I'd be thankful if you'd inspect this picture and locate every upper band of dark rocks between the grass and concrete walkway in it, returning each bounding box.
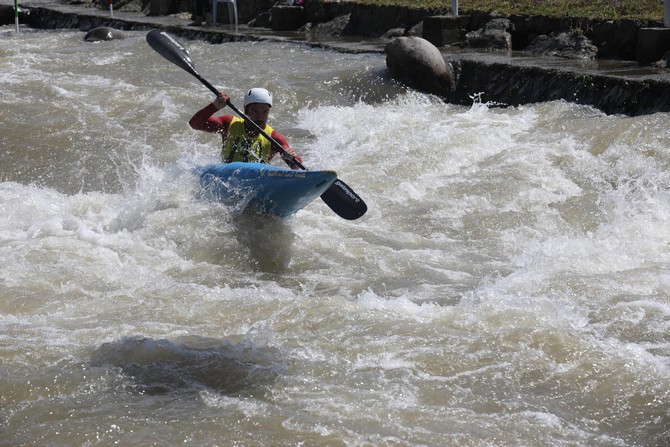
[46,0,670,63]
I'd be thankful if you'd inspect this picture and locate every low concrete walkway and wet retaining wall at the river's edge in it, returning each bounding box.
[0,0,670,116]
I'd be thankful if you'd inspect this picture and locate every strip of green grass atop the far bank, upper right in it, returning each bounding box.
[355,0,663,22]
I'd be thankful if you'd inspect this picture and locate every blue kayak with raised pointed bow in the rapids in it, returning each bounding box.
[198,162,337,217]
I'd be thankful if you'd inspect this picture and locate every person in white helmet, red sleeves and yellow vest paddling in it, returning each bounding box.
[188,88,302,169]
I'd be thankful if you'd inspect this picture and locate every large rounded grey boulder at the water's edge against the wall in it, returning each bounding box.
[385,36,454,96]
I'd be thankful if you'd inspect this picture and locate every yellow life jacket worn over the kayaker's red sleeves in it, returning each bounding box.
[221,117,272,163]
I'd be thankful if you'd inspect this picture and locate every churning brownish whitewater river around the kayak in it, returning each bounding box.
[0,27,670,447]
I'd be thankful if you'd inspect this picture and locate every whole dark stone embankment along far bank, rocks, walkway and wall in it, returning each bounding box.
[0,0,670,115]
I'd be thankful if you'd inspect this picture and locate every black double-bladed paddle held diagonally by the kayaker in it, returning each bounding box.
[147,29,368,220]
